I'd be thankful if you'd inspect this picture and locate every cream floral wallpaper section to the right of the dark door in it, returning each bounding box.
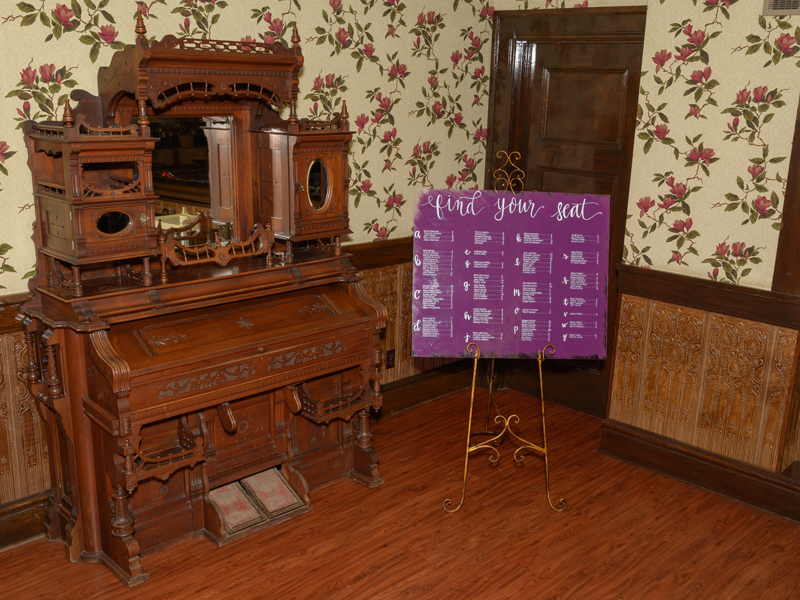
[624,0,800,289]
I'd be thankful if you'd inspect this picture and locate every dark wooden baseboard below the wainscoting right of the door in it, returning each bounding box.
[598,420,800,522]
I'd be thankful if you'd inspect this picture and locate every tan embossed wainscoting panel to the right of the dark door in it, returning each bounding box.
[609,294,798,472]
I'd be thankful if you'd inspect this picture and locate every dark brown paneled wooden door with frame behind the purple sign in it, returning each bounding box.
[484,6,647,417]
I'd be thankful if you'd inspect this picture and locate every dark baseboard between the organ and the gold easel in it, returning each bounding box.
[375,359,473,419]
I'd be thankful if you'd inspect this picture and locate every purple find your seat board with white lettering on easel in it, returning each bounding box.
[412,190,610,359]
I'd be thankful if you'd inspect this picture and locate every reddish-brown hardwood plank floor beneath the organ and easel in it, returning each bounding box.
[0,390,800,600]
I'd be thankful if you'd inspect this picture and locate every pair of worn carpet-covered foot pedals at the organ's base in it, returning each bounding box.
[208,468,310,534]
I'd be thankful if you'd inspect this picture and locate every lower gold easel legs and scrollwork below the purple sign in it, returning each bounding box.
[442,342,567,513]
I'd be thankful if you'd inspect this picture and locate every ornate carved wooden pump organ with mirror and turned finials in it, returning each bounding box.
[21,17,386,586]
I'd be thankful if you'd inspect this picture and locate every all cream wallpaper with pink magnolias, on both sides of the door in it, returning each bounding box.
[0,0,800,293]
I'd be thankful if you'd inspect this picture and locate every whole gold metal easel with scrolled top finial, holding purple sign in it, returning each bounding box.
[442,150,567,513]
